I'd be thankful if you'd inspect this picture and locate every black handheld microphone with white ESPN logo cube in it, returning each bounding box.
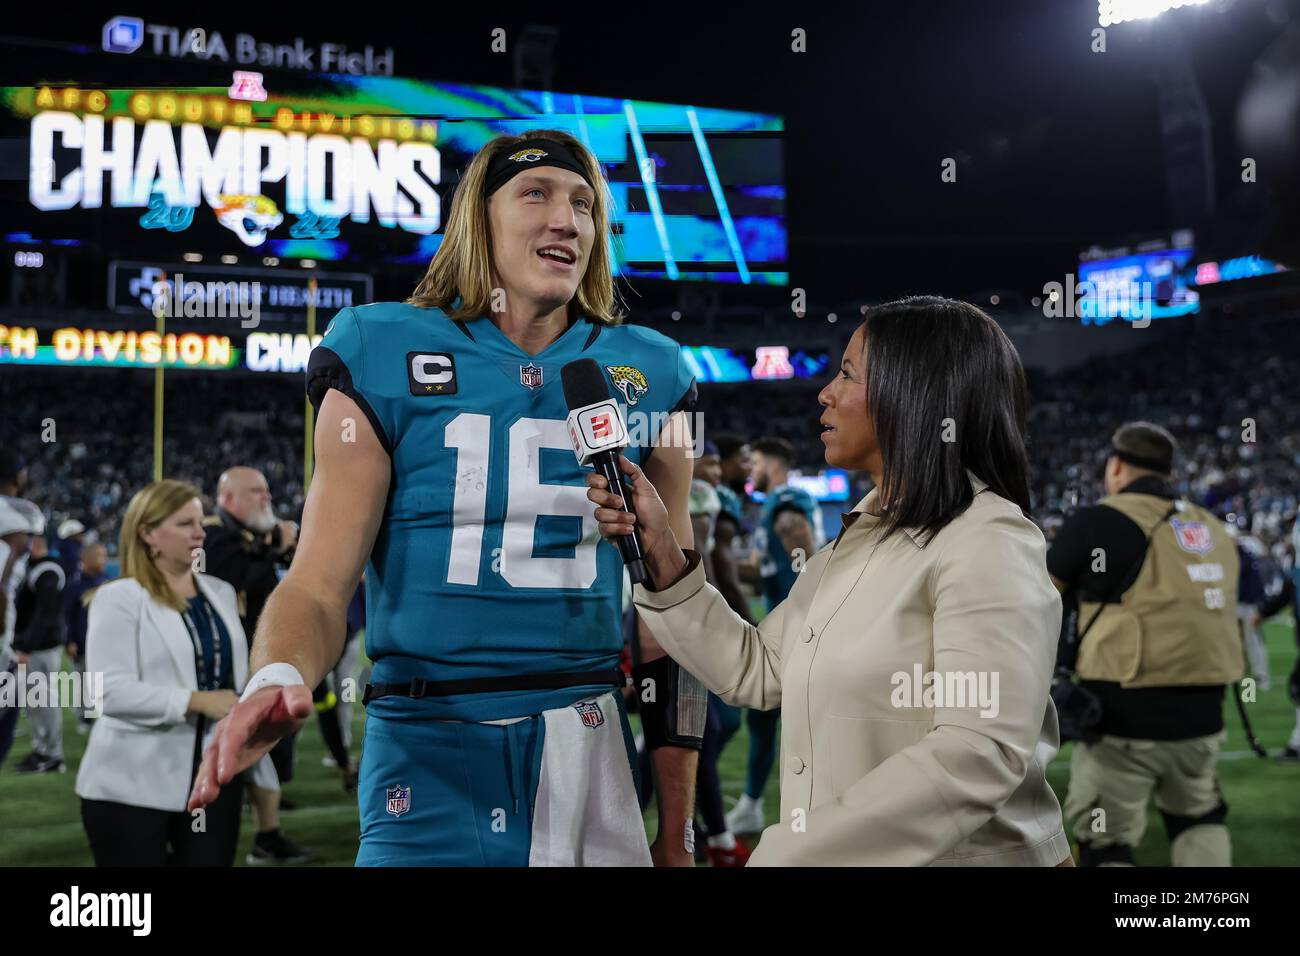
[560,359,650,584]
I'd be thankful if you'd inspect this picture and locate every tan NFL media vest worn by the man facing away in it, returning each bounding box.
[1078,493,1245,688]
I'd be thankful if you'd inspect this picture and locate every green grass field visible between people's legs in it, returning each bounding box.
[0,619,1300,866]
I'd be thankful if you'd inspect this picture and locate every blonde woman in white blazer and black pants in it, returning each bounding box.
[77,481,276,866]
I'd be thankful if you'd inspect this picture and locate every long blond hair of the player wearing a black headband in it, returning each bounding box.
[407,130,624,325]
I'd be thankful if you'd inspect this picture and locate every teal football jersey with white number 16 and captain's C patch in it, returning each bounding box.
[307,303,696,721]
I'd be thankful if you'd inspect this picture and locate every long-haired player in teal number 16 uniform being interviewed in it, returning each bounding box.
[190,130,705,865]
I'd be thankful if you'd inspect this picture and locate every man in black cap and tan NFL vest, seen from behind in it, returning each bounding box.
[1048,421,1245,866]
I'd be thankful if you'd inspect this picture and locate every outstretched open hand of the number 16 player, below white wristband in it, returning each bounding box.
[186,685,312,810]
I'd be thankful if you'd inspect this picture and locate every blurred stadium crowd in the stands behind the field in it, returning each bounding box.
[0,306,1300,564]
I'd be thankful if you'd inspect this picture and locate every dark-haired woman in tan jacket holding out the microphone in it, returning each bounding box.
[588,297,1070,866]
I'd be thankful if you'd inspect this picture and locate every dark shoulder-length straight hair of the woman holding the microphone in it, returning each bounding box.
[863,295,1030,542]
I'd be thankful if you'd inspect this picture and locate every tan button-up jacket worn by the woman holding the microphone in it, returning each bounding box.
[633,476,1070,866]
